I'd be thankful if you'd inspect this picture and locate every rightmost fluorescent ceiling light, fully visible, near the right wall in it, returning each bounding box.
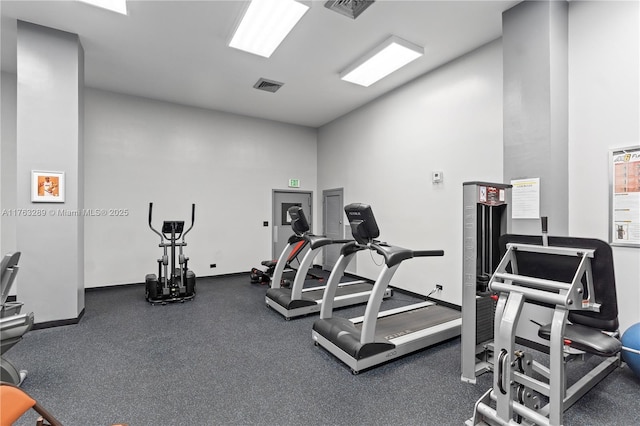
[340,36,424,87]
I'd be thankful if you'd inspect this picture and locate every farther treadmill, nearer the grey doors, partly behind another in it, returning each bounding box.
[265,206,393,320]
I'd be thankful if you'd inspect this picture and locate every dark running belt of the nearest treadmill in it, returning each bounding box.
[356,305,461,340]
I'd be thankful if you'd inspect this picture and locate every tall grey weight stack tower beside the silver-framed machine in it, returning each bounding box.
[461,182,511,383]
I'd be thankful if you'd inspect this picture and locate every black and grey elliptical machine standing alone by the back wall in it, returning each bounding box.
[145,203,196,305]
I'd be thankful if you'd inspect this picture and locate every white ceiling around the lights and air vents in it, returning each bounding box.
[0,0,519,127]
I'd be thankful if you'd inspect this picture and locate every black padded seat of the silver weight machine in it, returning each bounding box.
[538,324,622,356]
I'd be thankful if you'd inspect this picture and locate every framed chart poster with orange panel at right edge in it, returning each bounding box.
[609,146,640,247]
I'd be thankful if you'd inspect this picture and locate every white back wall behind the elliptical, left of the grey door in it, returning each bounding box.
[85,89,316,287]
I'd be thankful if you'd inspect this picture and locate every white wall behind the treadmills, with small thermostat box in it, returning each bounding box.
[318,40,502,304]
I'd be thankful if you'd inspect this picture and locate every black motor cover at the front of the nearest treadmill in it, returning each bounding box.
[313,318,396,359]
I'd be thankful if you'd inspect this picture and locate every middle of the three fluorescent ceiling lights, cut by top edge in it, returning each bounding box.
[229,0,309,58]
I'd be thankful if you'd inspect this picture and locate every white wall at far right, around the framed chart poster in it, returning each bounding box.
[569,1,640,330]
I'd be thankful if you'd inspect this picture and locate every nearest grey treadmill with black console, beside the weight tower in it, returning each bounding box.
[312,203,462,374]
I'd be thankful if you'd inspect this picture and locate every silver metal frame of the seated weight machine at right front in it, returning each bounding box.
[467,236,621,426]
